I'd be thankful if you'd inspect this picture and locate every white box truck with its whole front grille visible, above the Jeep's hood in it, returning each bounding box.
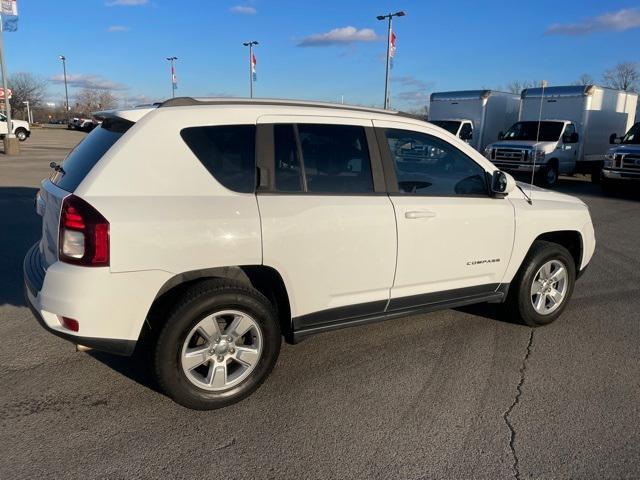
[484,85,638,186]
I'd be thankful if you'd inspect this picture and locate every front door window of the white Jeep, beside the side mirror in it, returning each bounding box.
[386,129,488,196]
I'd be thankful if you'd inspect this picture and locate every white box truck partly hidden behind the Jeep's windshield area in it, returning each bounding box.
[429,90,520,152]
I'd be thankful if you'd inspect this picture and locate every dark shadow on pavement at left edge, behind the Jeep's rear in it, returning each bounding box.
[0,187,42,306]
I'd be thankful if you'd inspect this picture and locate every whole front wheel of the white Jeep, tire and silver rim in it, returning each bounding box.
[505,241,576,327]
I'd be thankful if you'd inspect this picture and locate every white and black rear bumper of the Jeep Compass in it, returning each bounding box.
[23,244,171,355]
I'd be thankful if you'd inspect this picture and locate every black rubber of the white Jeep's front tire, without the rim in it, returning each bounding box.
[504,240,576,327]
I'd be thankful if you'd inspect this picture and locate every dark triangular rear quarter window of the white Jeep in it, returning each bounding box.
[180,125,256,193]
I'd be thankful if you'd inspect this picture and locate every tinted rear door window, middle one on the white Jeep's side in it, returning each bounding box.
[274,124,373,194]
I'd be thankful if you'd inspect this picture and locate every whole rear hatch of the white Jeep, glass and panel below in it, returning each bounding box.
[36,117,134,271]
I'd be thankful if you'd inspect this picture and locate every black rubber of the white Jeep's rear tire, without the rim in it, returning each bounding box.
[153,279,281,410]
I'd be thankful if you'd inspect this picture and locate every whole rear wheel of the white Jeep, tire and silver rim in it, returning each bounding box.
[154,280,281,410]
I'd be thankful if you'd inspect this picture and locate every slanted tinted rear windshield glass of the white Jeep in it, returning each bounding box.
[51,118,133,192]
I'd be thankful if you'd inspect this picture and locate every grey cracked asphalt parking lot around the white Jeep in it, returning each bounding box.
[0,130,640,479]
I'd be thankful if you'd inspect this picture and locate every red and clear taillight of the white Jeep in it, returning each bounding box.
[58,195,109,267]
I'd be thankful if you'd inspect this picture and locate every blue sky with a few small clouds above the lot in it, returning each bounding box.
[5,0,640,108]
